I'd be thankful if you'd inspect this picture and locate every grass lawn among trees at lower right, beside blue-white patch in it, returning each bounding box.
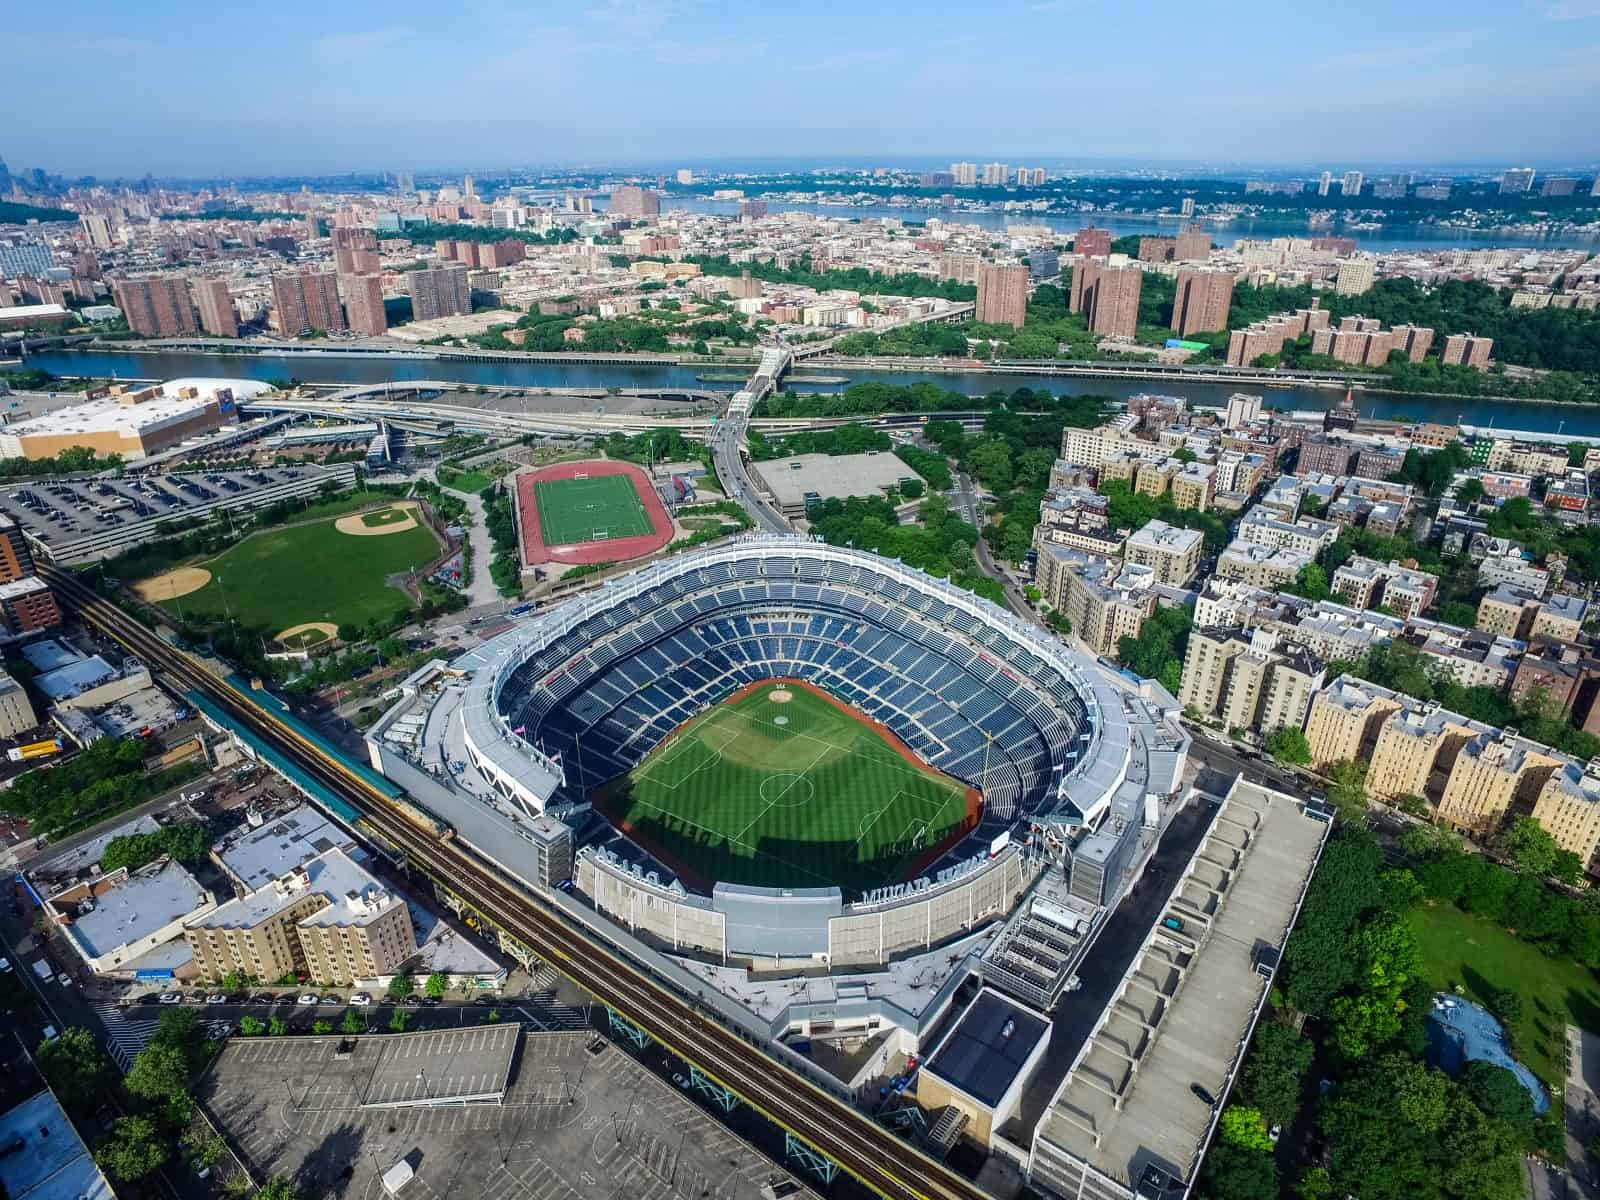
[1408,904,1600,1086]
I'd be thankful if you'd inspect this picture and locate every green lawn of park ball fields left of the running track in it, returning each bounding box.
[163,520,438,634]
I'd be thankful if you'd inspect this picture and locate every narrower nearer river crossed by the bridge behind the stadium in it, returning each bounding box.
[26,350,1600,437]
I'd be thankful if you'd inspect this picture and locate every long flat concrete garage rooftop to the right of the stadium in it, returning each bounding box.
[1035,779,1328,1190]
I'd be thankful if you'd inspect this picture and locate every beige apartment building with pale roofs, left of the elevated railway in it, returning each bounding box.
[184,848,416,987]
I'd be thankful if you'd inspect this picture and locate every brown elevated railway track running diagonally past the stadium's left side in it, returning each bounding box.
[50,565,986,1200]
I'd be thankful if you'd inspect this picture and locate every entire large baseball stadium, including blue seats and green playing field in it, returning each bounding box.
[454,534,1187,965]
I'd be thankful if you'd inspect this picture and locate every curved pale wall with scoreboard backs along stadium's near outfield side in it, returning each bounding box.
[576,846,1046,966]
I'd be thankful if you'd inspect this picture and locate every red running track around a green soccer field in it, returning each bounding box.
[517,461,672,566]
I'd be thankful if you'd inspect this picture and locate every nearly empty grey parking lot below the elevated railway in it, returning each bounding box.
[198,1026,810,1200]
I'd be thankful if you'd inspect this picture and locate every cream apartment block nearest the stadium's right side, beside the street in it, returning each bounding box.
[1178,627,1323,738]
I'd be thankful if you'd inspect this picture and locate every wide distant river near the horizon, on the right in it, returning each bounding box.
[643,197,1600,253]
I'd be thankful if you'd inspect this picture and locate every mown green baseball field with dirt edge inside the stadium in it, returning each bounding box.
[600,685,966,894]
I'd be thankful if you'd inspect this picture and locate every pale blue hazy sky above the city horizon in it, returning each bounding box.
[9,0,1600,178]
